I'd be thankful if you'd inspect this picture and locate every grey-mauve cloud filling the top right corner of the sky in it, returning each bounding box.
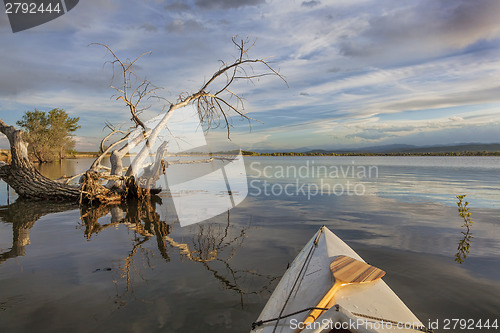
[340,0,500,61]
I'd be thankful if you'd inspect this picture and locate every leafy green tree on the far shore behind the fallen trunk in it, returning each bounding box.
[17,109,80,163]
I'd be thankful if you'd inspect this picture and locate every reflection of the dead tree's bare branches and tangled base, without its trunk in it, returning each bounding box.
[82,201,278,306]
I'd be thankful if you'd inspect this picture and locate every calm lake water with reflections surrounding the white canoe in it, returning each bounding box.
[0,157,500,332]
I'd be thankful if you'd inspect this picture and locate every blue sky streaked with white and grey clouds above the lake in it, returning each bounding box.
[0,0,500,151]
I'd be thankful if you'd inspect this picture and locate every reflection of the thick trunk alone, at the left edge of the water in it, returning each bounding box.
[0,199,78,262]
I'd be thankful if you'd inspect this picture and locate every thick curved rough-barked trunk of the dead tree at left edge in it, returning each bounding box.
[0,119,80,201]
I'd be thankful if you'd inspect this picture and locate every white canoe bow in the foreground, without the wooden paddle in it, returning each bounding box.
[252,227,428,333]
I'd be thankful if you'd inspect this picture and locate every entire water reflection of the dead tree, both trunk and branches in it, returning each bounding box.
[0,197,278,308]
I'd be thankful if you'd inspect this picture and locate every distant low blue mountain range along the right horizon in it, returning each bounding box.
[255,143,500,154]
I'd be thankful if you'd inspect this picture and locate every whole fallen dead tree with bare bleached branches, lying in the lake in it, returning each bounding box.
[0,38,286,204]
